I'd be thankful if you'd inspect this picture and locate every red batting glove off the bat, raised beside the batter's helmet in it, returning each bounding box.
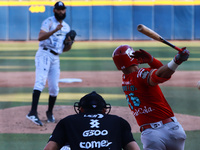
[131,49,153,64]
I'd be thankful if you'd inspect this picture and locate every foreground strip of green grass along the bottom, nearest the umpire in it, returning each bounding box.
[0,131,200,150]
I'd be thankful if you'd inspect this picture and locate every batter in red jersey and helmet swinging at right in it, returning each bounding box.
[112,45,189,150]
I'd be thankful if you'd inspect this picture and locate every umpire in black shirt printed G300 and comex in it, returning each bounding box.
[44,91,140,150]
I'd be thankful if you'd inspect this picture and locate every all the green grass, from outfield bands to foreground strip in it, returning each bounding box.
[0,41,200,150]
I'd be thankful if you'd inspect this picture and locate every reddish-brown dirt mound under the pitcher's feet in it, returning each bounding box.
[0,105,200,134]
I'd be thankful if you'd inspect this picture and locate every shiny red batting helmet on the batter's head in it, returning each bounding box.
[112,45,138,70]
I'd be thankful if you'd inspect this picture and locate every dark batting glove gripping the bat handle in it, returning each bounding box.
[174,47,190,65]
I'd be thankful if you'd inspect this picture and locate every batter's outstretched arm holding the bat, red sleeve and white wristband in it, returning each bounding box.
[149,49,189,86]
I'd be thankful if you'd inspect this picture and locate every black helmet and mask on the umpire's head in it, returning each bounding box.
[74,91,111,114]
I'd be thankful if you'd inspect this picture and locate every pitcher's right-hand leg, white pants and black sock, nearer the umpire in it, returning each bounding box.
[46,56,60,122]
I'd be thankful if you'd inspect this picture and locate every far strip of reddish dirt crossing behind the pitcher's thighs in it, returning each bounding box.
[0,71,200,87]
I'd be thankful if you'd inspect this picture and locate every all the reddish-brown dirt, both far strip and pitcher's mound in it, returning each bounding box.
[0,71,200,134]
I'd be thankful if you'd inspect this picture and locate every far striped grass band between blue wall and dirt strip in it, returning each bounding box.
[0,41,200,71]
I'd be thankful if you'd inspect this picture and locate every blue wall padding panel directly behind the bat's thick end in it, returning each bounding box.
[133,6,153,40]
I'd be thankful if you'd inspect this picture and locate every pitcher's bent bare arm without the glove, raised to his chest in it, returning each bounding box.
[38,24,63,41]
